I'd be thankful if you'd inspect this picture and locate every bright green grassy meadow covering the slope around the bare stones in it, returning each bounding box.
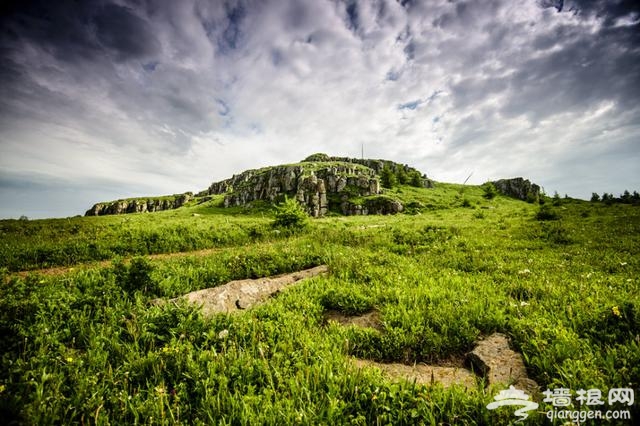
[0,184,640,425]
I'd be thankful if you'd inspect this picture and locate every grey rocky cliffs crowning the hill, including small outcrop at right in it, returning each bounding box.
[85,153,540,217]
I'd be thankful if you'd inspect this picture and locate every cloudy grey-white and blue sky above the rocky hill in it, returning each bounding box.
[0,0,640,218]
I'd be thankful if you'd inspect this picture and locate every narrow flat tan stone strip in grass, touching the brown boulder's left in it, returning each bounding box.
[352,358,477,389]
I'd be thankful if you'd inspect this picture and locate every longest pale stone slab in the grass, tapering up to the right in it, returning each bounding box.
[160,265,328,315]
